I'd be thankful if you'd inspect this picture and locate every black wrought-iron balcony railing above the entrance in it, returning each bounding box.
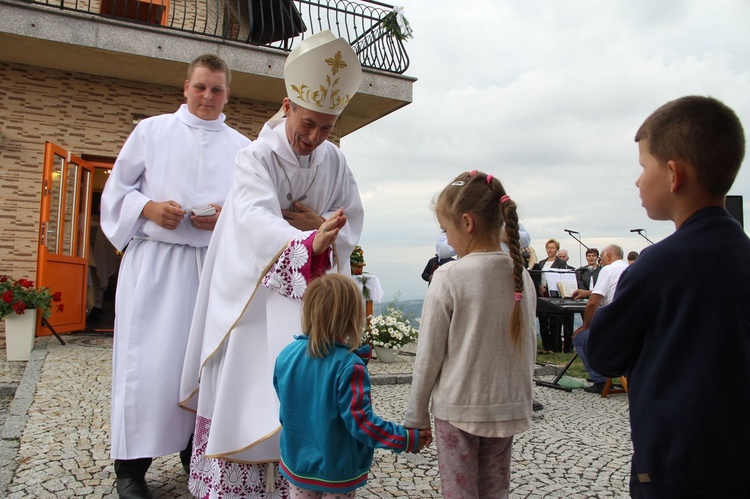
[22,0,409,74]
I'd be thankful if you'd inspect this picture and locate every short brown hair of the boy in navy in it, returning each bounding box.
[635,95,745,195]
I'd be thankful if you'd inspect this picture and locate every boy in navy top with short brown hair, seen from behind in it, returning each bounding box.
[587,96,750,499]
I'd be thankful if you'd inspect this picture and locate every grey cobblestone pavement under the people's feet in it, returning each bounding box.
[0,334,632,498]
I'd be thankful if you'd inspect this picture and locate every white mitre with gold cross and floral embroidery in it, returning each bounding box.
[284,30,362,116]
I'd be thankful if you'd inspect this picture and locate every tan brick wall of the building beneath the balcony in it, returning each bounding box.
[0,62,338,330]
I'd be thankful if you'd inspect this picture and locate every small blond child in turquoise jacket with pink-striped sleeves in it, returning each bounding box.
[273,274,432,498]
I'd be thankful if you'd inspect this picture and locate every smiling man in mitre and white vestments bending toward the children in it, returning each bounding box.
[181,31,363,498]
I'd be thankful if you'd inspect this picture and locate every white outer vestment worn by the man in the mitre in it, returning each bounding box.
[180,119,363,463]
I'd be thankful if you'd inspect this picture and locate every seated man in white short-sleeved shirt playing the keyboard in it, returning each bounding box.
[573,244,628,393]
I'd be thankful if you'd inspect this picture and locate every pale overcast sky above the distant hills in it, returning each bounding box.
[342,0,750,301]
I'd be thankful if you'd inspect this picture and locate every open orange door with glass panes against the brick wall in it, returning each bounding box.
[37,142,94,334]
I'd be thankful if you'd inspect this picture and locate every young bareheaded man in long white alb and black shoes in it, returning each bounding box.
[101,54,250,498]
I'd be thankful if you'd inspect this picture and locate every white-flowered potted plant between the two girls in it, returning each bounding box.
[364,303,419,362]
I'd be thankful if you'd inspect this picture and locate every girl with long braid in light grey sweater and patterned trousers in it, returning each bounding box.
[405,170,536,498]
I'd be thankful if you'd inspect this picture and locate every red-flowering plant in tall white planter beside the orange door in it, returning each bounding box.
[0,275,64,360]
